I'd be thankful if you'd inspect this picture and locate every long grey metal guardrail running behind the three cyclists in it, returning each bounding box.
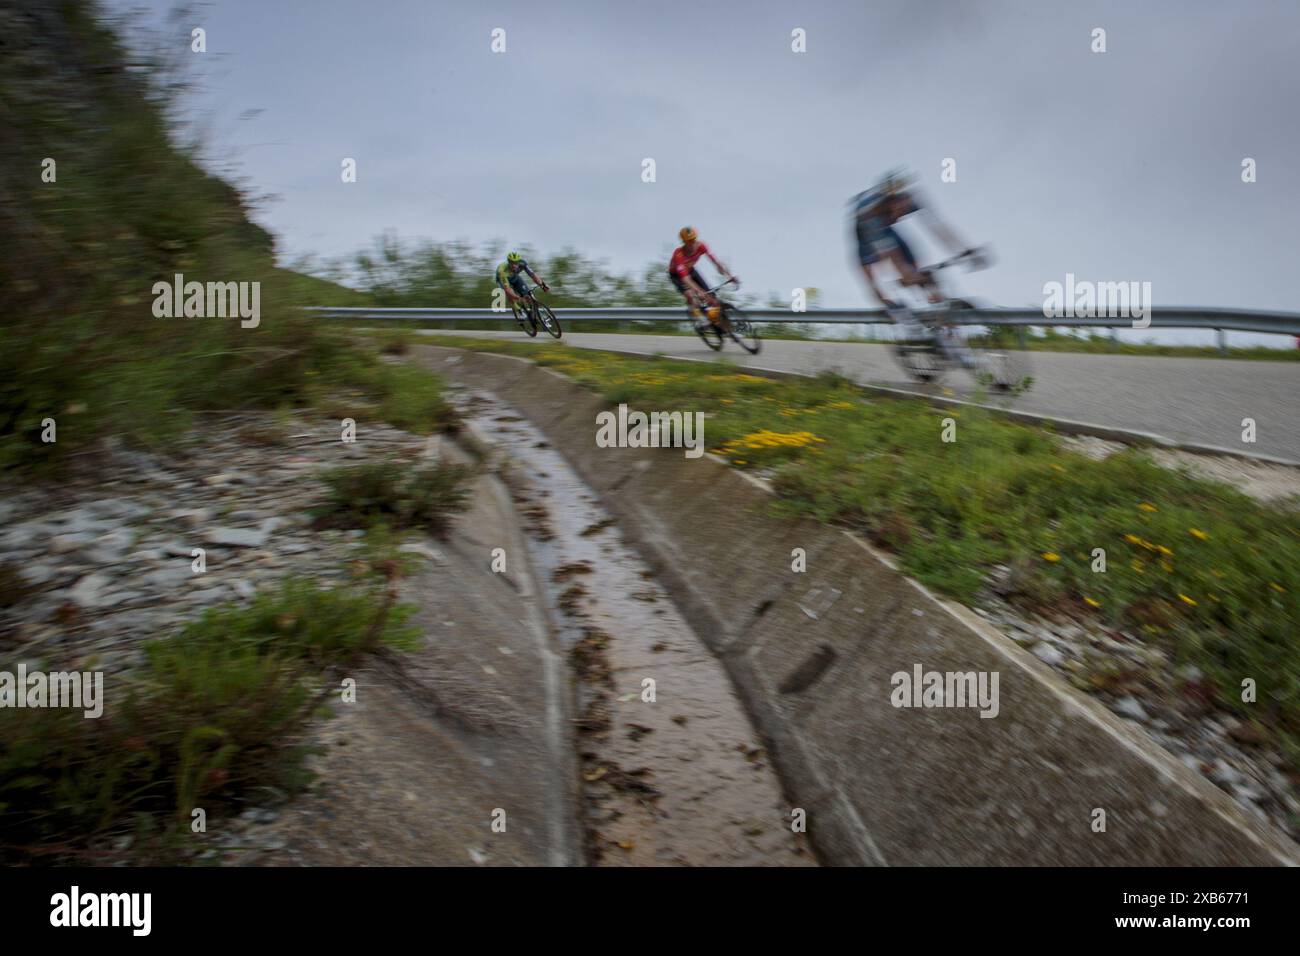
[307,307,1300,341]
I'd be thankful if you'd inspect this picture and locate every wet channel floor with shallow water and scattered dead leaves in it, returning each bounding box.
[455,390,815,866]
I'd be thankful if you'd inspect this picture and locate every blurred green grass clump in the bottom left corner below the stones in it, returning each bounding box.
[0,579,417,864]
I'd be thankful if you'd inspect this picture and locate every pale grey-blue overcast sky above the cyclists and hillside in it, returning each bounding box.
[108,0,1300,310]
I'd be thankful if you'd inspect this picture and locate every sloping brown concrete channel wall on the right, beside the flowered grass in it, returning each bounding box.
[417,346,1297,866]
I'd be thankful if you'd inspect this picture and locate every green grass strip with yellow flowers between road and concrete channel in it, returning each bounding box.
[441,338,1300,766]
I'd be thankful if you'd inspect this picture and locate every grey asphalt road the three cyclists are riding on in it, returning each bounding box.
[423,332,1300,463]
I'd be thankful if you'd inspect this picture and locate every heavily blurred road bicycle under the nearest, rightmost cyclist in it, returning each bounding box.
[889,250,1034,392]
